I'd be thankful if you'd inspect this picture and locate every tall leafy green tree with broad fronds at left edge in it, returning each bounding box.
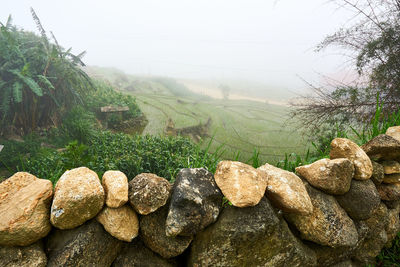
[0,9,94,135]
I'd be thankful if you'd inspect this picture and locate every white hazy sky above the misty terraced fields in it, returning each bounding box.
[0,0,350,89]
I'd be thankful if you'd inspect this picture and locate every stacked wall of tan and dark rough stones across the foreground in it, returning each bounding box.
[0,127,400,267]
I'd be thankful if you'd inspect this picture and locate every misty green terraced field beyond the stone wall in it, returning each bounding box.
[85,66,307,163]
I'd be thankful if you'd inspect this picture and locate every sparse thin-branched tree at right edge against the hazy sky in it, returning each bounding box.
[293,0,400,129]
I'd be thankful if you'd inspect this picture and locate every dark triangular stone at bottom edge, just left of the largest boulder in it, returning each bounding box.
[111,241,178,267]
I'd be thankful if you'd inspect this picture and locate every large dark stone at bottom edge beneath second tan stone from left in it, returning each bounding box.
[46,220,123,267]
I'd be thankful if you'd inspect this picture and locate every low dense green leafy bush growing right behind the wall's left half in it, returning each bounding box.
[17,132,219,182]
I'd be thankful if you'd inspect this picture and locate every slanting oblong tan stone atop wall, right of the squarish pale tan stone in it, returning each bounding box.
[258,164,313,214]
